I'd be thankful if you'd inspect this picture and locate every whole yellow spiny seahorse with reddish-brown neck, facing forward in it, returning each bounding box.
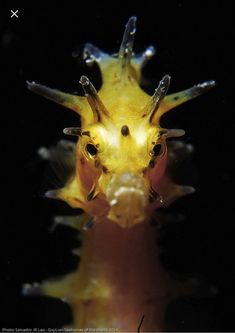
[23,17,215,332]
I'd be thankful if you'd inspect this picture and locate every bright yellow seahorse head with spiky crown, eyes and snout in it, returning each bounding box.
[28,17,214,227]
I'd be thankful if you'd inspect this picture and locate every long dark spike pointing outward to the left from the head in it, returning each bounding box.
[26,81,82,113]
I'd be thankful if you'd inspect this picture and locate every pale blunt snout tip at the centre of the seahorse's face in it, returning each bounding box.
[106,172,148,228]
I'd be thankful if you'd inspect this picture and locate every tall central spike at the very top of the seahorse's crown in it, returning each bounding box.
[118,16,136,71]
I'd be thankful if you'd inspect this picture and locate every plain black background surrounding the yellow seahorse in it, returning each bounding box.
[0,1,235,331]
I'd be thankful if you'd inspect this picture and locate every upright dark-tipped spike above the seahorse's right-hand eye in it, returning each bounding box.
[147,75,171,122]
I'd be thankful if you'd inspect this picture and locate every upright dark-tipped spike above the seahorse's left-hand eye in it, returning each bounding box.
[79,75,109,122]
